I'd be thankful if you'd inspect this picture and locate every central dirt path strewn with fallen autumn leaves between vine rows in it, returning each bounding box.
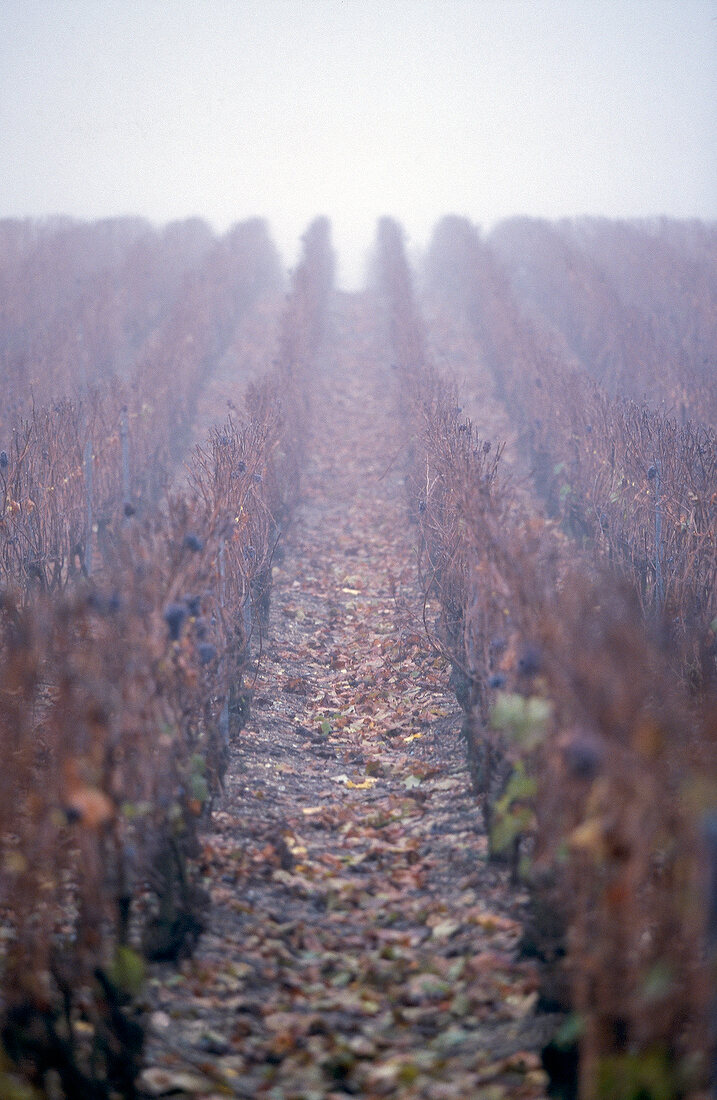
[142,297,548,1100]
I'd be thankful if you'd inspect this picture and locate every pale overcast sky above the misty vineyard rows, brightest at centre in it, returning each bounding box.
[0,0,717,285]
